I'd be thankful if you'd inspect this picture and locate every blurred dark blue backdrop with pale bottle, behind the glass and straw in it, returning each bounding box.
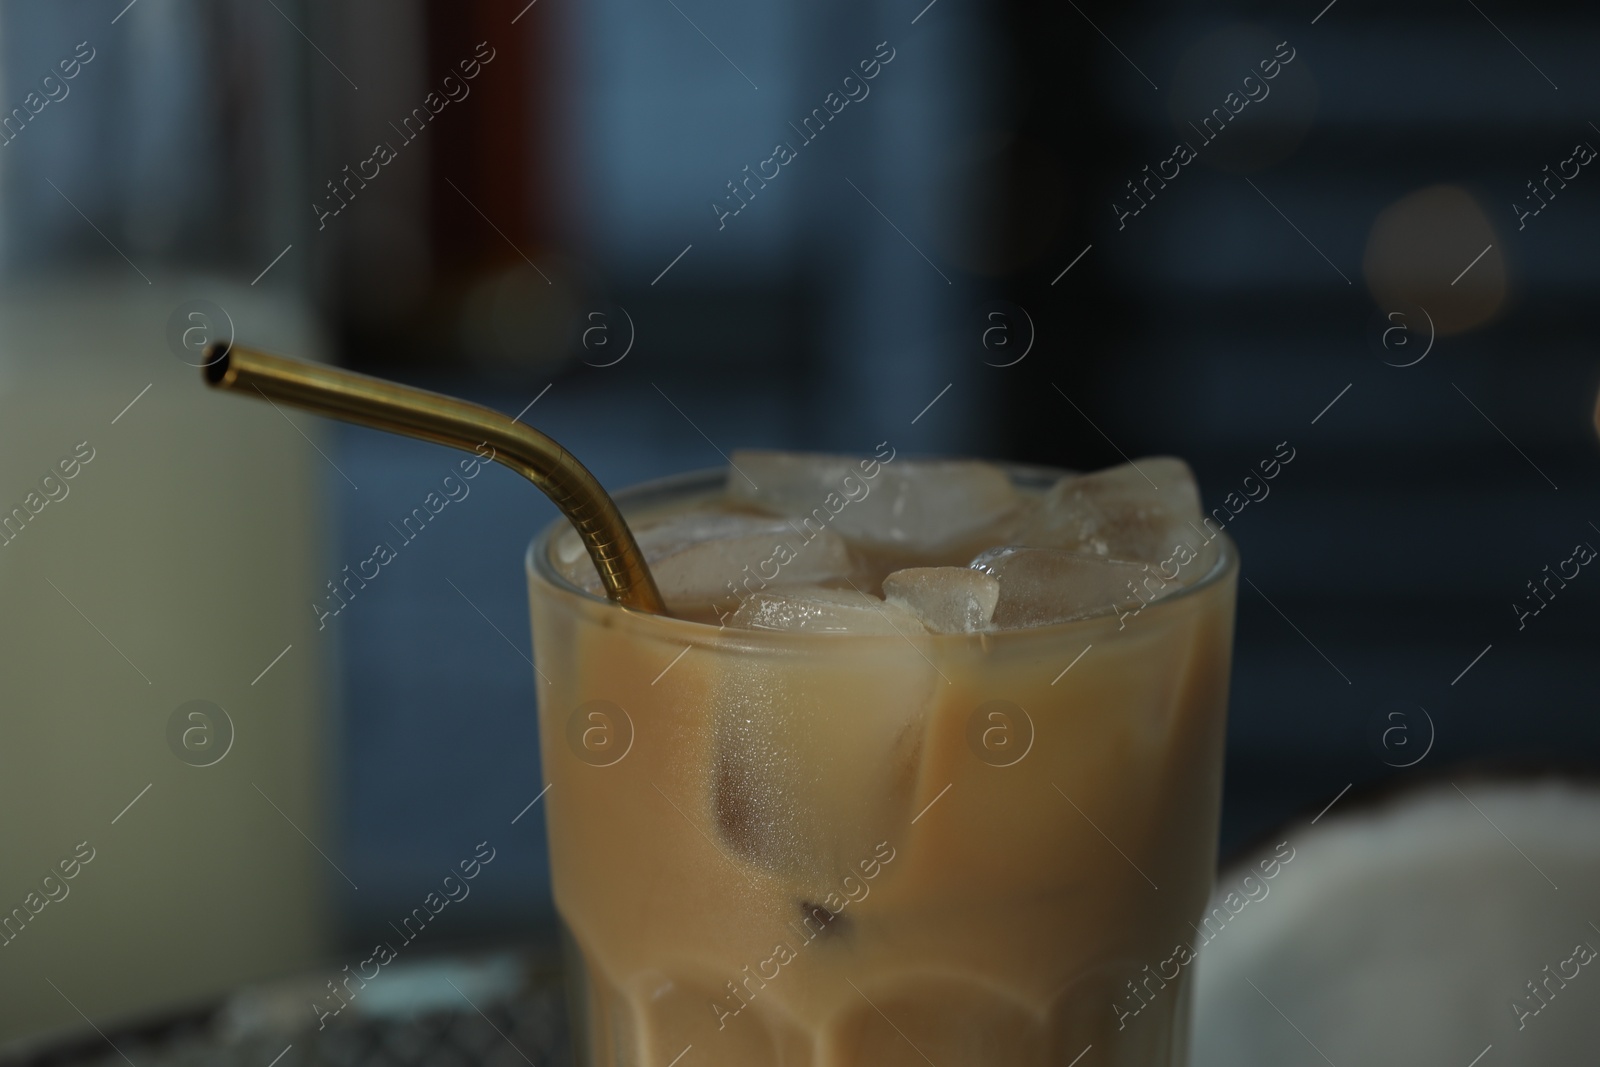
[0,0,1600,1040]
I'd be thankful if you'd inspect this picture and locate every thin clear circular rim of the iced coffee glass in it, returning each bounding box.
[523,461,1238,640]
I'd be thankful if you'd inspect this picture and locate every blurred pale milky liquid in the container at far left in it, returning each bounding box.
[0,272,337,1043]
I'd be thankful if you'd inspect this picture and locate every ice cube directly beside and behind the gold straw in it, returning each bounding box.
[557,510,858,608]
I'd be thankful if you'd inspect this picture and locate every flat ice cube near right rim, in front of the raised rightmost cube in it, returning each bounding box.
[971,545,1181,629]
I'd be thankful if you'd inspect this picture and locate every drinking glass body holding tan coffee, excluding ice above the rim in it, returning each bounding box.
[528,467,1238,1067]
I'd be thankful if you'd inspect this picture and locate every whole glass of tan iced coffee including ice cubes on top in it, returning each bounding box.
[528,443,1237,1067]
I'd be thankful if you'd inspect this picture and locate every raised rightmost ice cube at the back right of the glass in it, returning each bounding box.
[1011,456,1205,563]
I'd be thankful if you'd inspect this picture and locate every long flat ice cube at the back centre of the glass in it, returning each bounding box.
[728,451,1019,552]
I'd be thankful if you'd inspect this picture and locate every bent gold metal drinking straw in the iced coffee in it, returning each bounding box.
[200,337,667,614]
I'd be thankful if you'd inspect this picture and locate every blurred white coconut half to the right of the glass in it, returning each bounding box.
[1190,776,1600,1067]
